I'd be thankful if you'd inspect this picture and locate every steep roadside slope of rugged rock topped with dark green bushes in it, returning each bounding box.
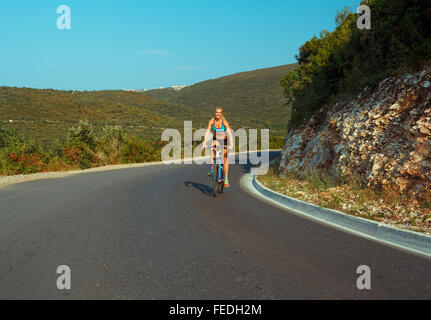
[279,0,431,206]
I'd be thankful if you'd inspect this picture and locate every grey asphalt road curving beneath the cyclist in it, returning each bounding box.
[0,153,431,299]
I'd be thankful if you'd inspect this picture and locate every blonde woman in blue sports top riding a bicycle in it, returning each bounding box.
[203,107,233,188]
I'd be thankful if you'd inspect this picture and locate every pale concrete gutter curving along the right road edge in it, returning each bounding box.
[241,174,431,259]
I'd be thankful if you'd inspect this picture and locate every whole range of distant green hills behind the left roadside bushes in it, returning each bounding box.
[0,65,294,144]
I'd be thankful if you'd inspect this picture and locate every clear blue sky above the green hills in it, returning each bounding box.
[0,0,360,90]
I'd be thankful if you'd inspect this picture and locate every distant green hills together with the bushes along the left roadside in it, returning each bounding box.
[0,66,293,175]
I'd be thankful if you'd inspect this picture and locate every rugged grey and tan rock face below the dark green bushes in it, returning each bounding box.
[280,69,431,199]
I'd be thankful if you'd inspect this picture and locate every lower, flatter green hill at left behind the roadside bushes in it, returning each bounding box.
[0,87,191,145]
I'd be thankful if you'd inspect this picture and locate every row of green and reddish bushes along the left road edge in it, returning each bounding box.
[0,121,162,175]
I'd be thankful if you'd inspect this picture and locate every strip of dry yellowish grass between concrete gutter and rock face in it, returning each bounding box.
[259,161,431,235]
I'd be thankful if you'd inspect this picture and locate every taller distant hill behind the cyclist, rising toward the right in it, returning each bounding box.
[145,64,296,135]
